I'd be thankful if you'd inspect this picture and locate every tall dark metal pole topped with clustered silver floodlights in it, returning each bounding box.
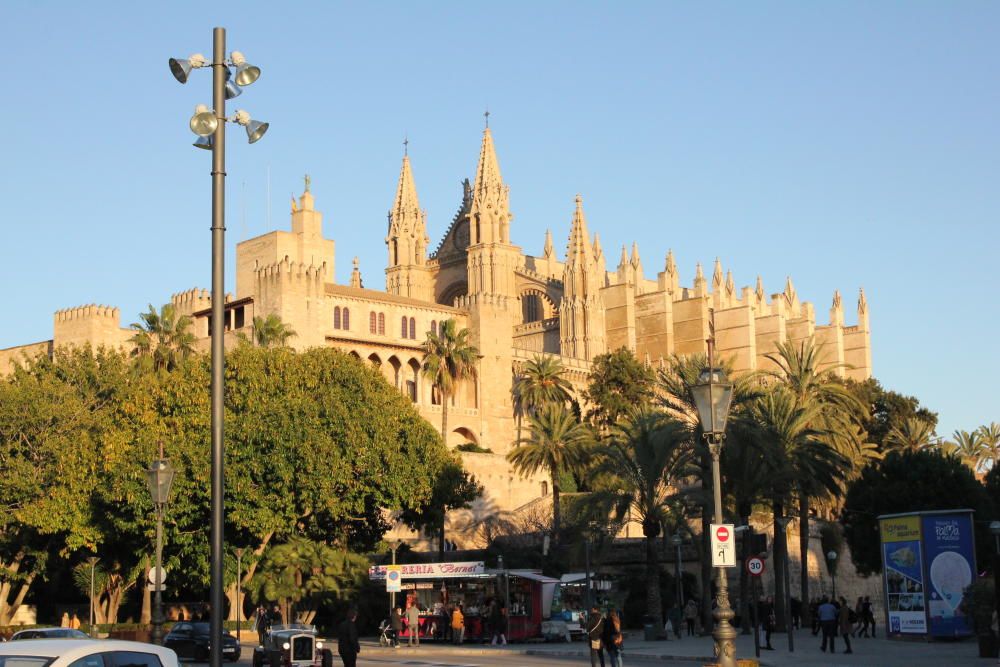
[169,28,268,667]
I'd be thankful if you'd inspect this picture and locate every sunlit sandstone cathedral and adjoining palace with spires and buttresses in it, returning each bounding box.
[0,127,871,548]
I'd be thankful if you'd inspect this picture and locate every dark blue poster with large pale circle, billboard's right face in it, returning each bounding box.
[921,512,976,637]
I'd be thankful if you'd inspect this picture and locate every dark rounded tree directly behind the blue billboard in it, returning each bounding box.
[840,449,994,576]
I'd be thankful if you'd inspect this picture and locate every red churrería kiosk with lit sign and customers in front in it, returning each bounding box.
[368,561,559,642]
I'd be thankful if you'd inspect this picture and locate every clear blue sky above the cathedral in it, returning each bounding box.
[0,2,1000,435]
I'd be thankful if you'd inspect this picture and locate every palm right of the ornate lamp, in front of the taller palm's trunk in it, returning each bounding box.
[753,385,850,623]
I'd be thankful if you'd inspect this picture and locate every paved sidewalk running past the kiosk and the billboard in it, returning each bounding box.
[362,632,995,667]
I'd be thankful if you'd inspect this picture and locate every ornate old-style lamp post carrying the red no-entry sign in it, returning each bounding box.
[691,311,736,667]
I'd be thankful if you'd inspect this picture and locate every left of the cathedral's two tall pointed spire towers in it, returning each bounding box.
[385,155,434,301]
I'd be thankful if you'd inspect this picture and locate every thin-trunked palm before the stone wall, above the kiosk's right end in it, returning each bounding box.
[507,403,593,544]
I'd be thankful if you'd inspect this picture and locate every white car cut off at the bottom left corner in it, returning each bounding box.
[0,639,178,667]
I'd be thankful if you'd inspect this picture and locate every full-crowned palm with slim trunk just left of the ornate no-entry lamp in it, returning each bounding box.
[595,408,698,627]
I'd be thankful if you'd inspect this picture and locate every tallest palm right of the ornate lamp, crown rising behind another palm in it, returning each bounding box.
[764,337,874,624]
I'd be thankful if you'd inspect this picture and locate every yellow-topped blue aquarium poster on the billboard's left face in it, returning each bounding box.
[880,516,927,634]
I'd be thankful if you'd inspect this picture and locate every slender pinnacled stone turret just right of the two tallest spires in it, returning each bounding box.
[559,195,607,361]
